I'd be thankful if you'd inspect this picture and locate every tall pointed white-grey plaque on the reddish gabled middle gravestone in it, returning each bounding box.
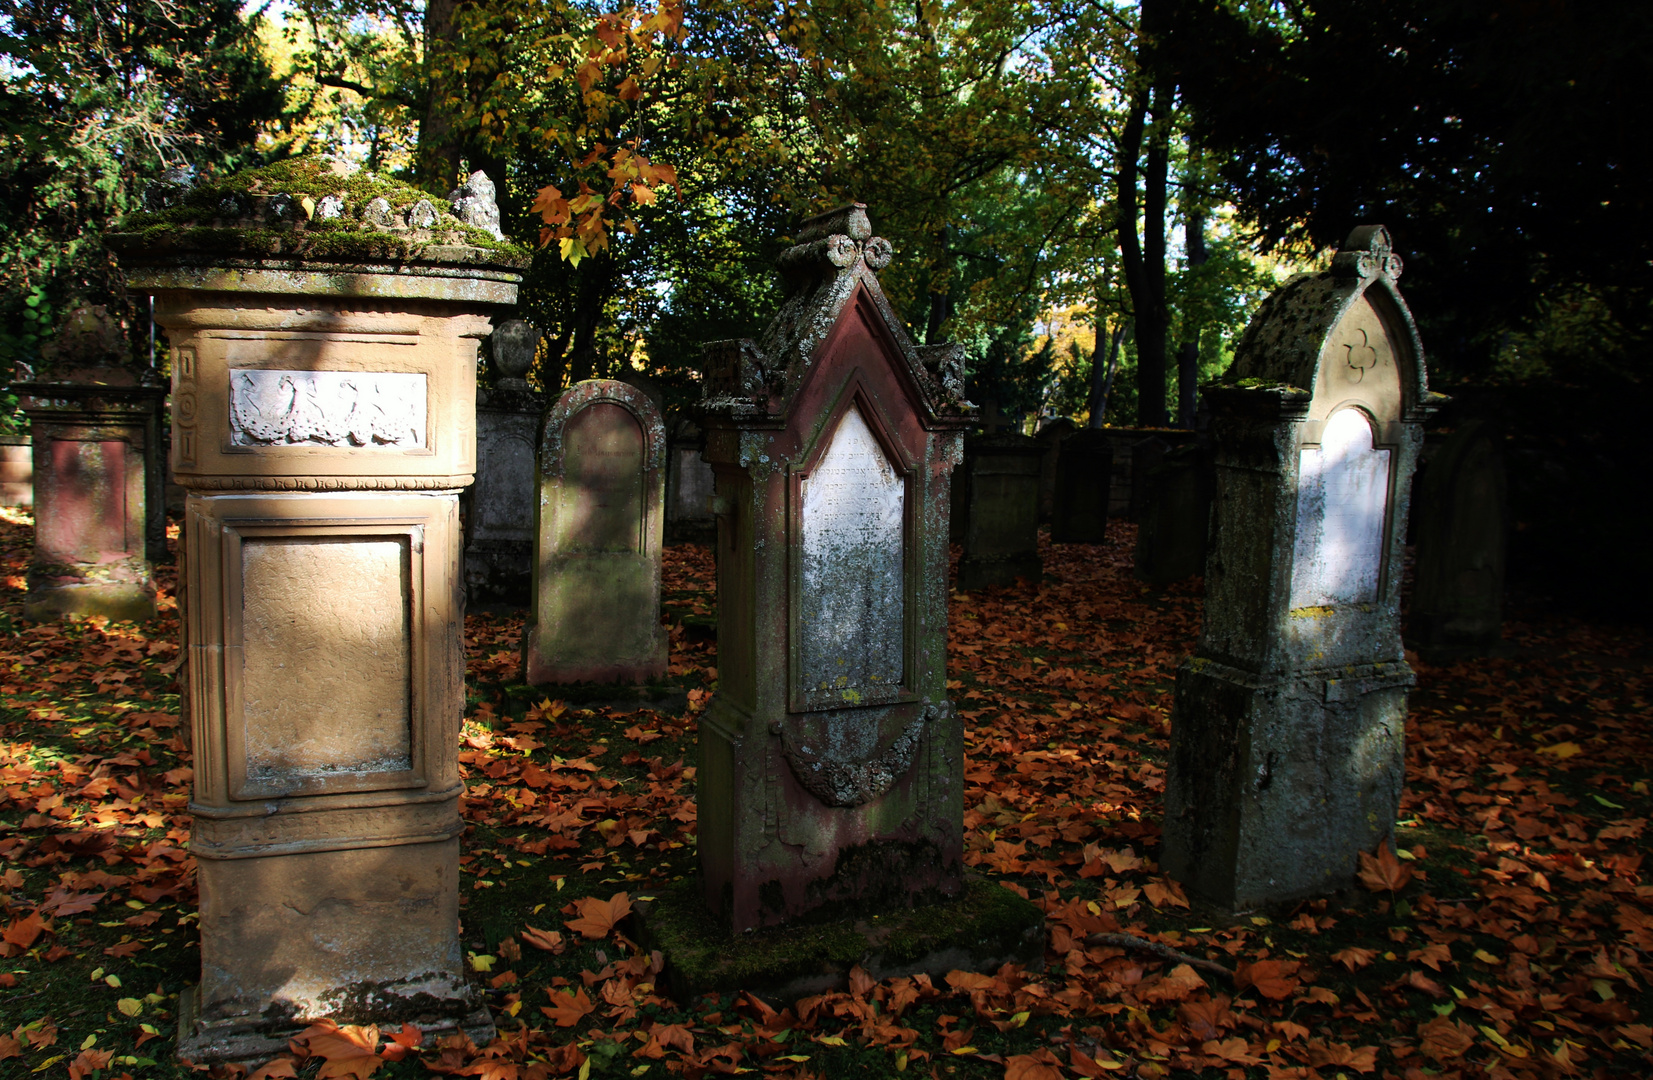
[797,405,906,708]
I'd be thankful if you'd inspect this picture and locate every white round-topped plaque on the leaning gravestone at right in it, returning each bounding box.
[1291,409,1389,609]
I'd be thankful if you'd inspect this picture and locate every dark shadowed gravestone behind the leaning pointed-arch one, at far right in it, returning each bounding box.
[1407,420,1509,662]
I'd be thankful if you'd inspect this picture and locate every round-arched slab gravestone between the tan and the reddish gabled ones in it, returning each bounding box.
[524,379,666,685]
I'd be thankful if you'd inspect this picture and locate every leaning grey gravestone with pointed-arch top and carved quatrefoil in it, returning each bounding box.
[1160,225,1443,910]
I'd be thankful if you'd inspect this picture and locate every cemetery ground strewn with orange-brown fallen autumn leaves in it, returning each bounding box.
[0,509,1653,1080]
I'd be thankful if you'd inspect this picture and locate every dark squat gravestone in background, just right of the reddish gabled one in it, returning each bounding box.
[952,433,1045,589]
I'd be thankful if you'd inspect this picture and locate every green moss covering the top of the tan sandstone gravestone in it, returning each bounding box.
[104,155,532,266]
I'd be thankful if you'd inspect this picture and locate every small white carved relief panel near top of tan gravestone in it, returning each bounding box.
[230,367,428,450]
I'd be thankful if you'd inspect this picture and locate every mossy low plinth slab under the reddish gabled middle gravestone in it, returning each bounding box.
[633,878,1045,1006]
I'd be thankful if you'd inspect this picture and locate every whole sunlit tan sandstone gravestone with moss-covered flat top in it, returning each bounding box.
[107,159,526,1062]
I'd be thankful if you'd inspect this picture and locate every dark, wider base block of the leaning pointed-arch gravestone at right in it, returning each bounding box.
[1160,657,1413,911]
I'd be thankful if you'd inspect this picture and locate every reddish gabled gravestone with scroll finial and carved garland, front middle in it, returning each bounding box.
[698,203,971,934]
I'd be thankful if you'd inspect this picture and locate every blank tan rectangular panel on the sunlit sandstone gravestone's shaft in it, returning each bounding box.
[241,536,413,789]
